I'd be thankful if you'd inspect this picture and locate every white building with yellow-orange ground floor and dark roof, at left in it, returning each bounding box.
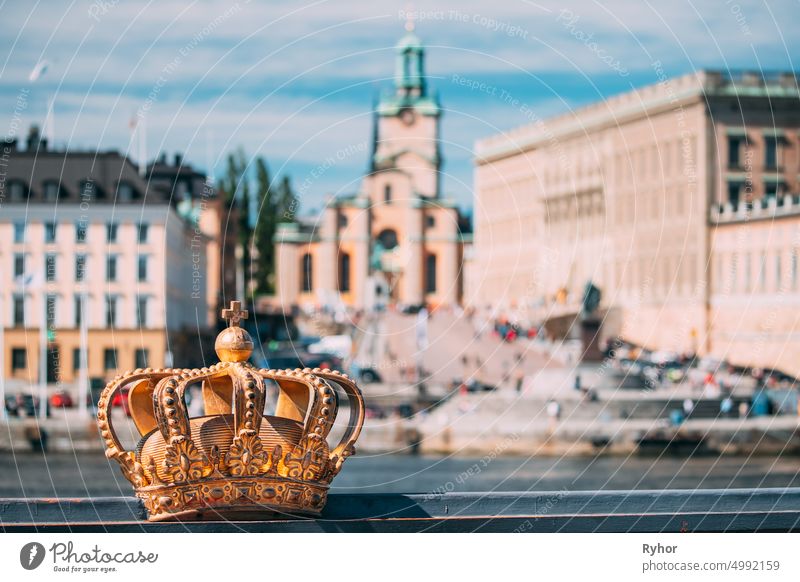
[0,133,216,390]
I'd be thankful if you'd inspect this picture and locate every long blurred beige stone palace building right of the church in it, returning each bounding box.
[467,70,800,373]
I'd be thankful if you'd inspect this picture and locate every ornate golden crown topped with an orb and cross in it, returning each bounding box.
[97,301,364,521]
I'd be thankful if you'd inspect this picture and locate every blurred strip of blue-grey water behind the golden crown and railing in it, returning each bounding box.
[0,453,800,497]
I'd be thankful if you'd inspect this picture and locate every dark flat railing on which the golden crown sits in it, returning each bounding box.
[0,488,800,533]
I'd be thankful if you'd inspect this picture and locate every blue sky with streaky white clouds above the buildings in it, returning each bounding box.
[0,0,800,212]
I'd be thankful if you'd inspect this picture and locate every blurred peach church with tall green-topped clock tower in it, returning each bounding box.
[275,30,469,309]
